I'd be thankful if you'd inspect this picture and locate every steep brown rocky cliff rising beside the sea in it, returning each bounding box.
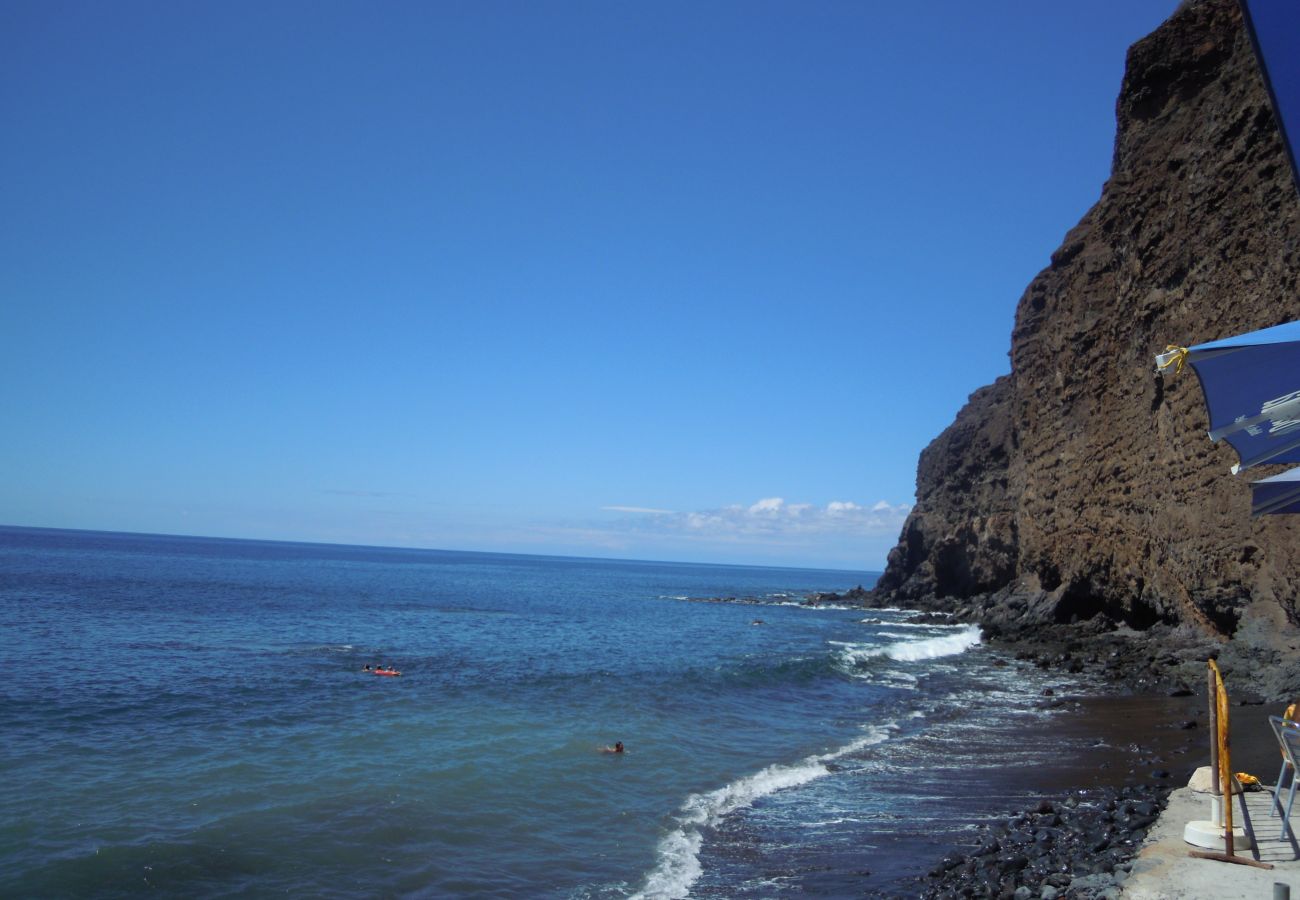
[875,0,1300,693]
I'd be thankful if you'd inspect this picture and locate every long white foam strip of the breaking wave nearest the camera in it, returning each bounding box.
[632,723,897,900]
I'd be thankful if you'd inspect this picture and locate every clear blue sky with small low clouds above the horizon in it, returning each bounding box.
[0,0,1175,568]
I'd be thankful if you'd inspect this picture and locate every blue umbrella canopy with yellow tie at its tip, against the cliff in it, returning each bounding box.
[1158,321,1300,472]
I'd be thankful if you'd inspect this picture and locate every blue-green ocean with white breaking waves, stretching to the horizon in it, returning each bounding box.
[0,528,1138,900]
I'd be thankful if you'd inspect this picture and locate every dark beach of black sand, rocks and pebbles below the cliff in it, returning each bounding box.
[809,588,1300,900]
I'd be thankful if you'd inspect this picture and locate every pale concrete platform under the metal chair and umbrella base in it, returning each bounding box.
[1121,788,1300,900]
